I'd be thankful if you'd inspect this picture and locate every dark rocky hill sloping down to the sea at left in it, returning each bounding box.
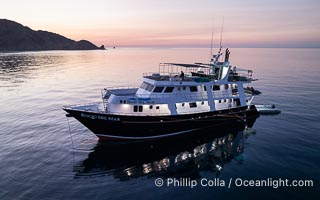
[0,19,105,51]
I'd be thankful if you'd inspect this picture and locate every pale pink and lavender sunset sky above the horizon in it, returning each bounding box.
[0,0,320,47]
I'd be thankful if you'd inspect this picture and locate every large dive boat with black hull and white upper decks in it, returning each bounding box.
[63,48,259,140]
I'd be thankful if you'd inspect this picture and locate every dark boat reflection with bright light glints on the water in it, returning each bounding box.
[74,115,256,181]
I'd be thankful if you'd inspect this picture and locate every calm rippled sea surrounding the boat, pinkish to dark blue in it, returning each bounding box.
[0,48,320,199]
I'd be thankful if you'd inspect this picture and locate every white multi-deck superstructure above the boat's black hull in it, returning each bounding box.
[103,49,253,116]
